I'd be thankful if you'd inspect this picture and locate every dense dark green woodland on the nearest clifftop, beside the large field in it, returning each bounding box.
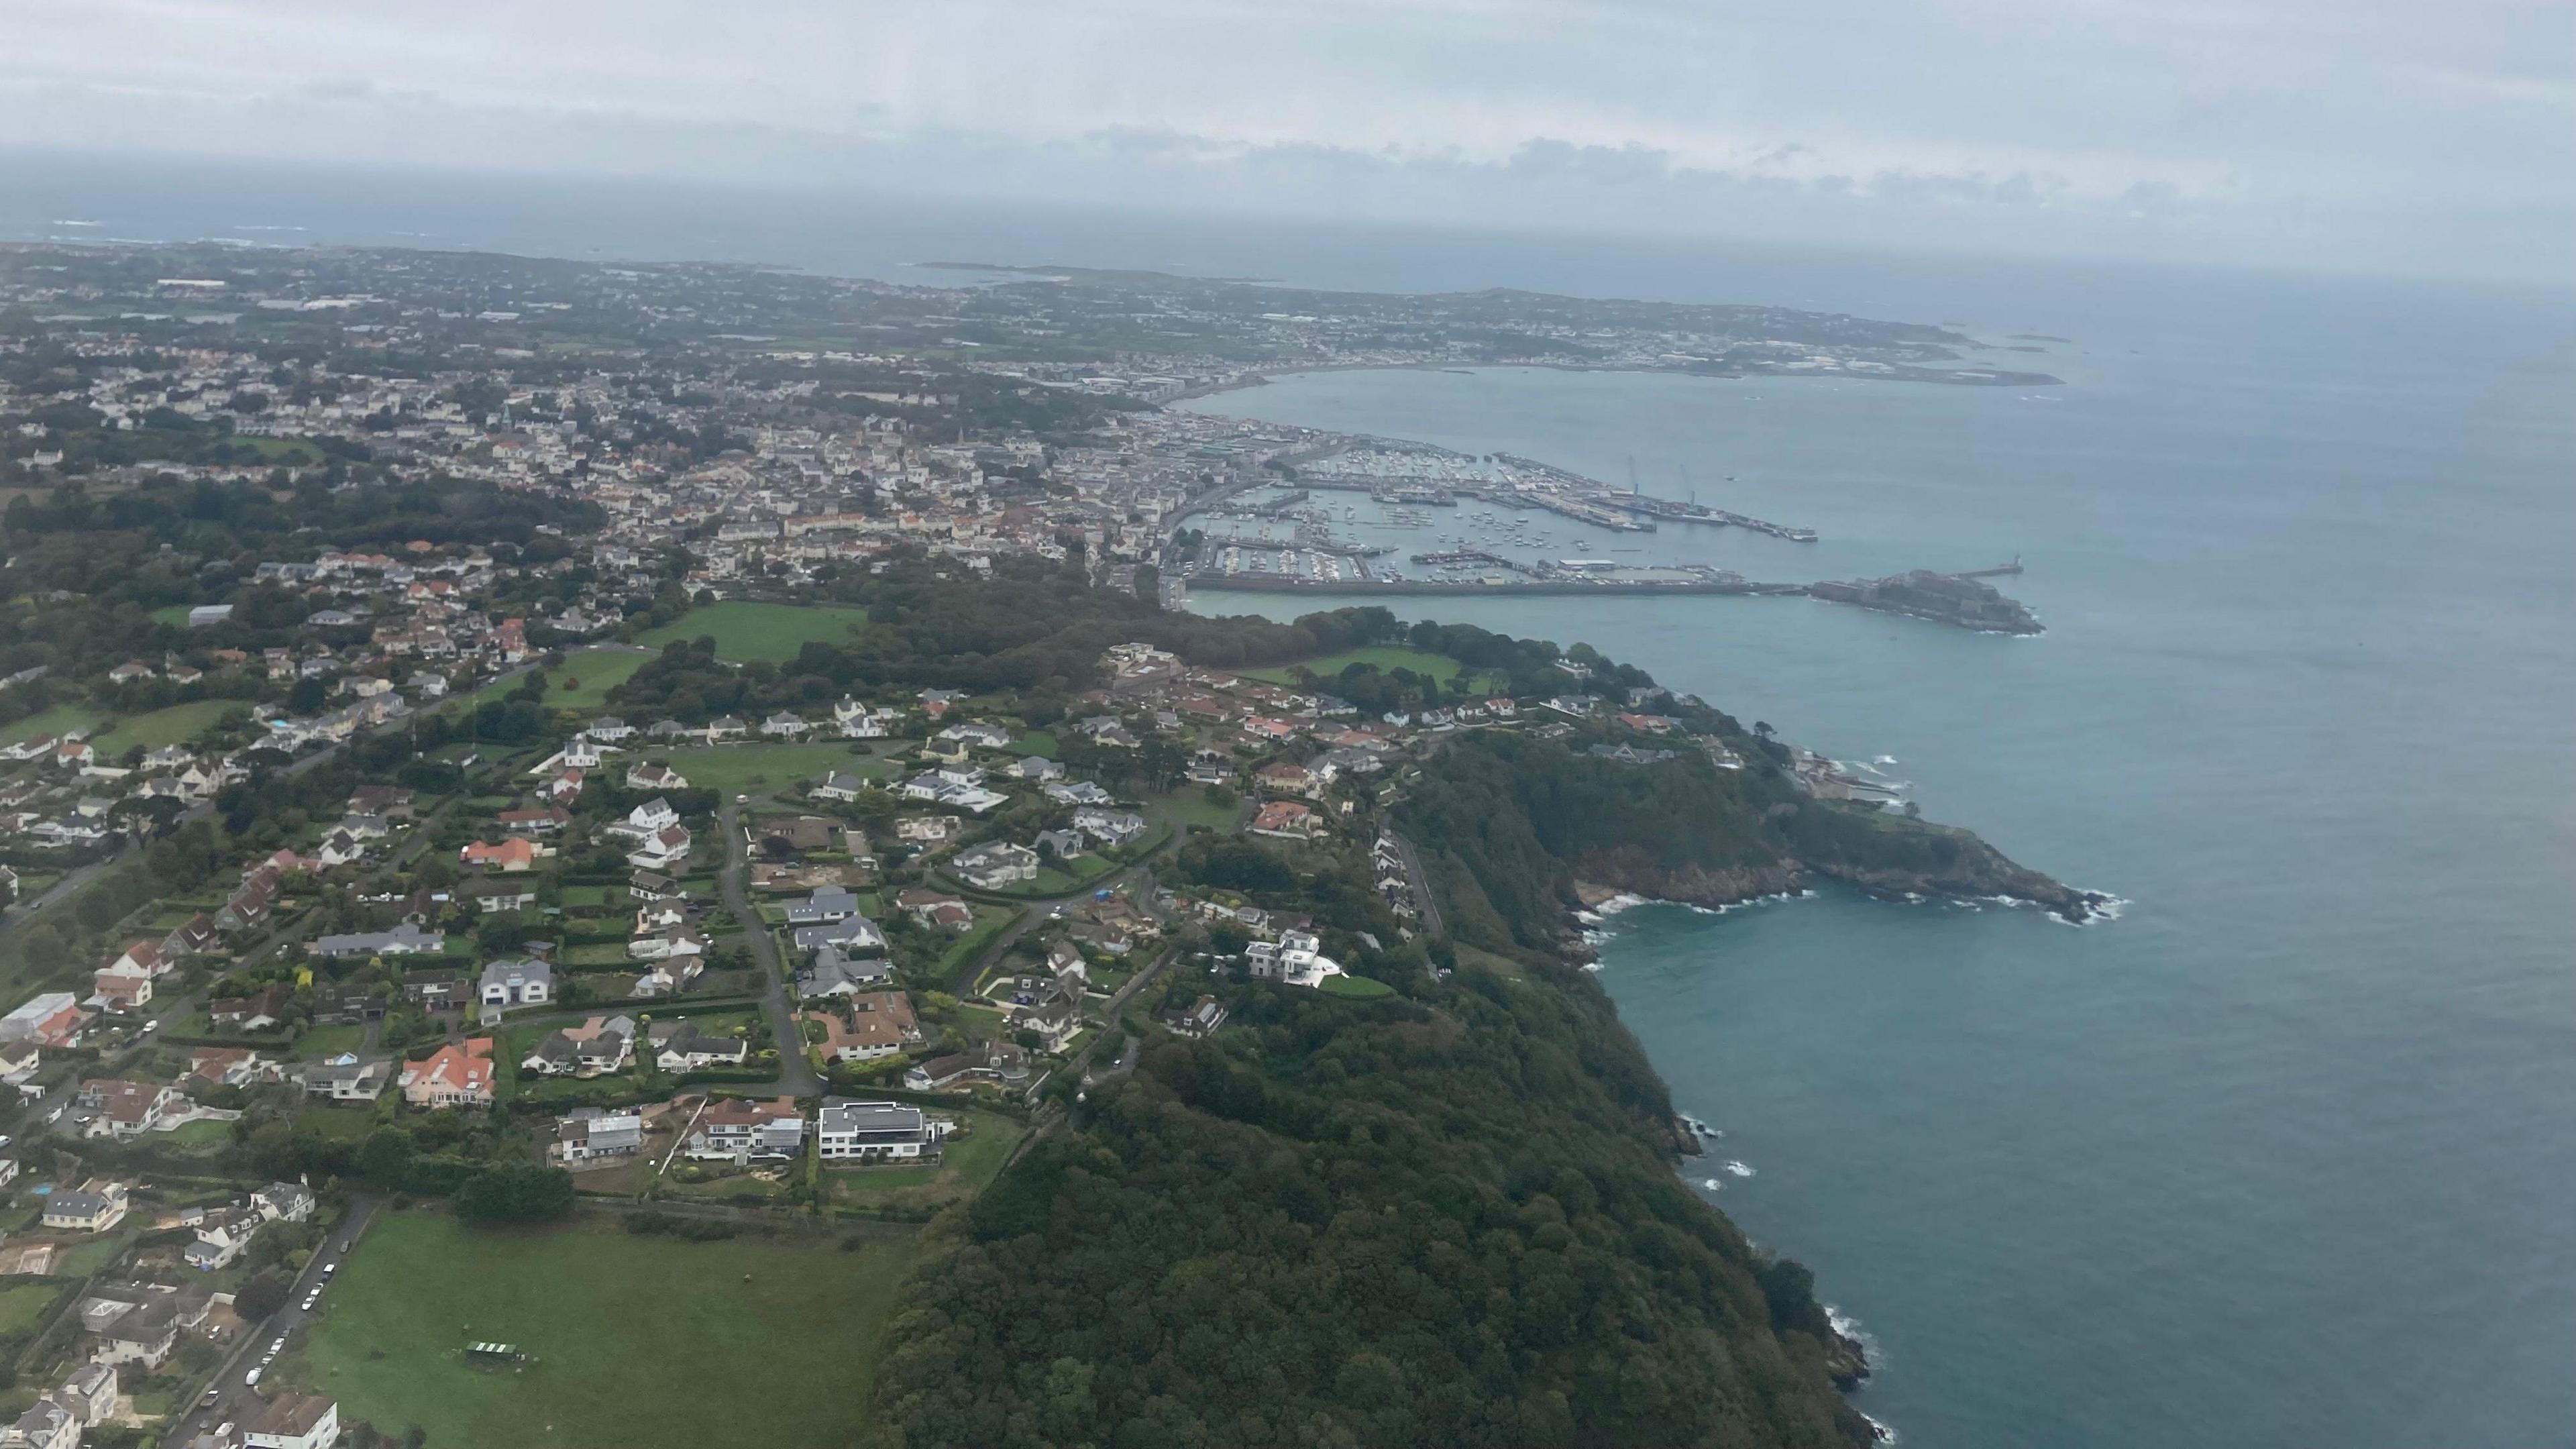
[876,967,1870,1449]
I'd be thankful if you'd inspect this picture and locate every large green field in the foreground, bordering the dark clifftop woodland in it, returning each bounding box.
[278,1212,912,1449]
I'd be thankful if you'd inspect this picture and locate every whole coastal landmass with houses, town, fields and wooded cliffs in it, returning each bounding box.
[0,248,2107,1449]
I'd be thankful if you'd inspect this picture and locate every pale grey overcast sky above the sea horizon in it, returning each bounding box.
[0,0,2576,286]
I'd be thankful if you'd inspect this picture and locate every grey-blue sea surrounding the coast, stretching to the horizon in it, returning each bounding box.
[0,155,2576,1449]
